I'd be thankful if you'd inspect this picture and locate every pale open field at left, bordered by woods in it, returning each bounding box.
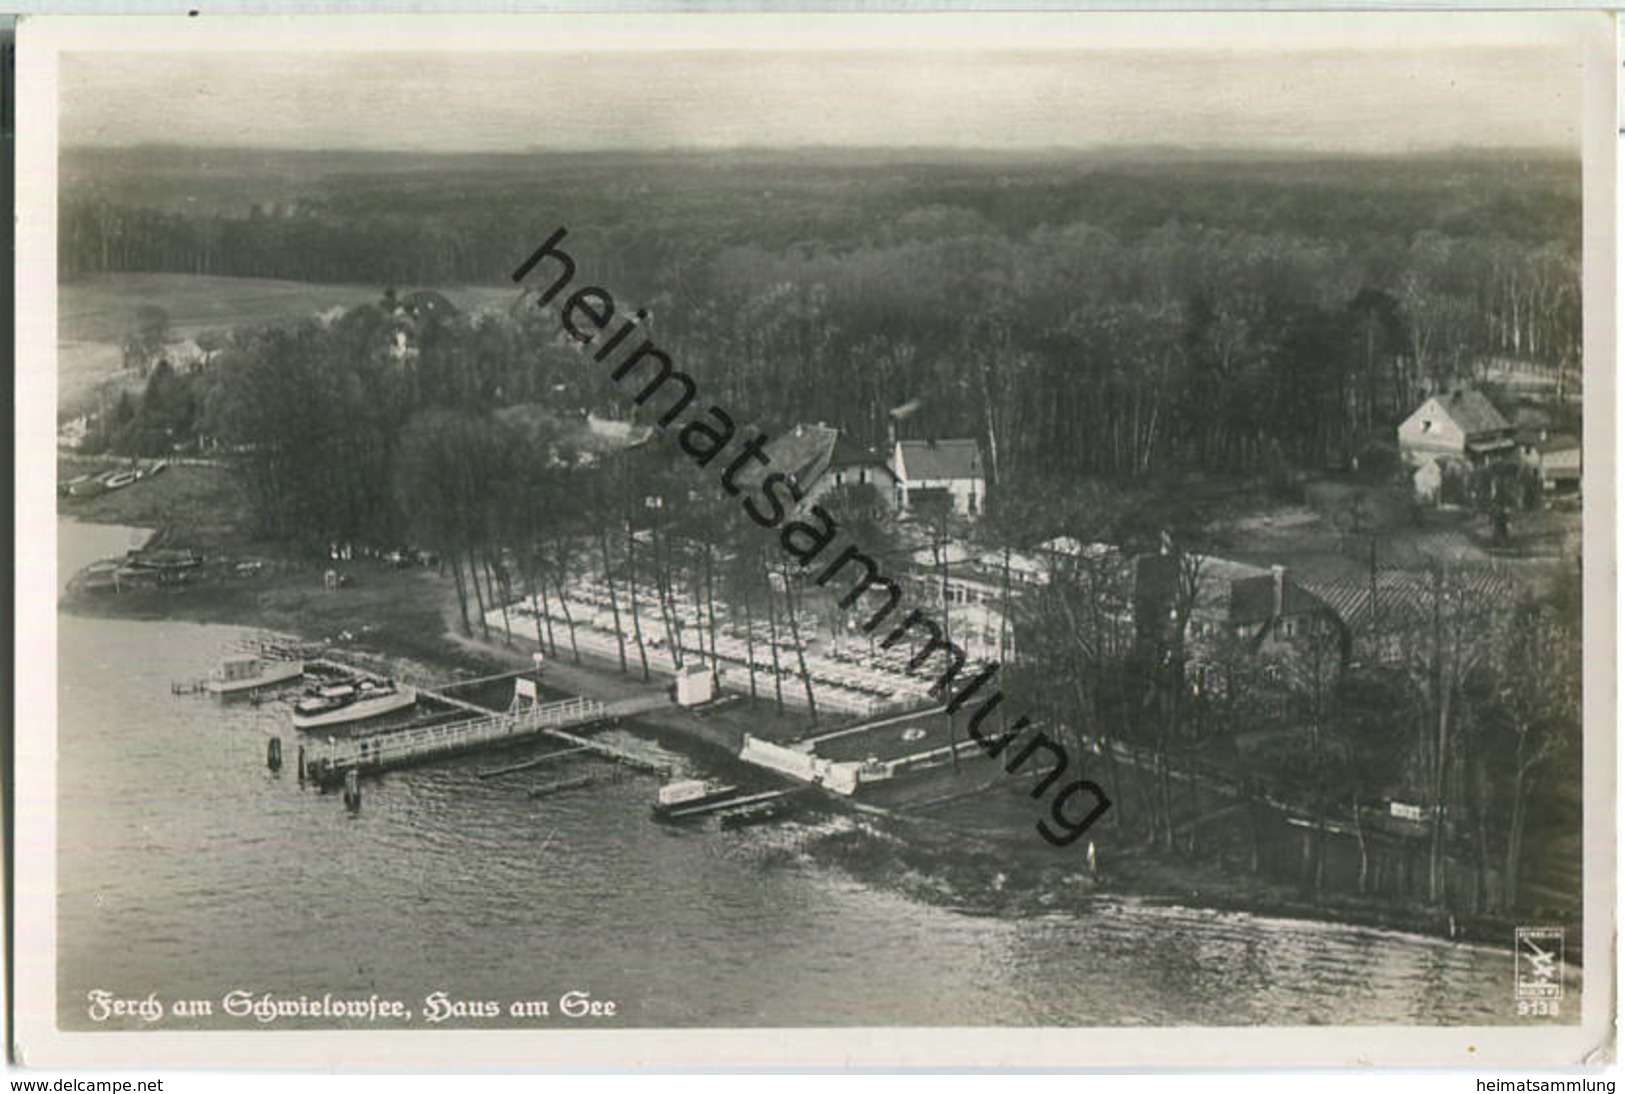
[57,273,514,410]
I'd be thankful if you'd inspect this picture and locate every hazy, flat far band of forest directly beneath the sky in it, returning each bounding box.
[60,148,1580,293]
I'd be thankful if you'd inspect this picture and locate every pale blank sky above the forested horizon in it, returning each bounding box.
[59,16,1581,153]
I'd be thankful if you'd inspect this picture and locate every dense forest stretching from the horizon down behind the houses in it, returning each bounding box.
[73,151,1581,481]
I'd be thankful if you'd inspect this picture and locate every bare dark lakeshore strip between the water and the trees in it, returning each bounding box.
[57,507,1547,964]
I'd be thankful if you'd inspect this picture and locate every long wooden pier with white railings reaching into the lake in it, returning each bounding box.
[306,689,668,787]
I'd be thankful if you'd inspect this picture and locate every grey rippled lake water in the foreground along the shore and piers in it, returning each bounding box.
[59,522,1573,1029]
